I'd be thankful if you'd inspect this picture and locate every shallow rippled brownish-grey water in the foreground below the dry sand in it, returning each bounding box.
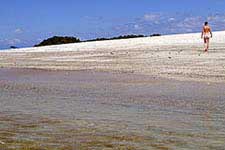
[0,68,225,150]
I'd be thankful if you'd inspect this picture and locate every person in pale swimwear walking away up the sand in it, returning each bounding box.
[201,22,212,52]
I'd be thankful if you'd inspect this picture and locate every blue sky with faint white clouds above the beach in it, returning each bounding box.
[0,0,225,49]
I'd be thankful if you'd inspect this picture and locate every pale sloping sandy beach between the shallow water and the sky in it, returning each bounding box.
[0,31,225,82]
